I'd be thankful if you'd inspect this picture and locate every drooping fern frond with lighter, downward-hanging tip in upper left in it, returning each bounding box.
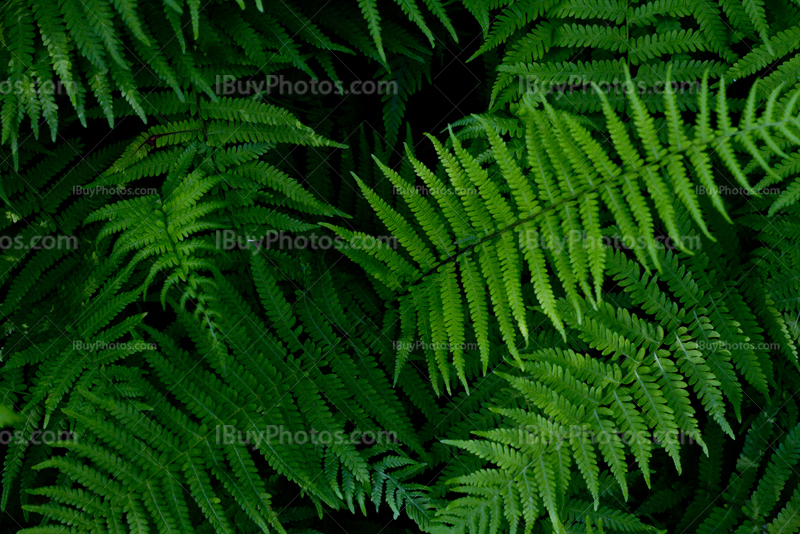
[84,91,350,367]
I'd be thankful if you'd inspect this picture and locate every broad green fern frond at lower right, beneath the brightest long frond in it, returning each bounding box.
[428,201,798,534]
